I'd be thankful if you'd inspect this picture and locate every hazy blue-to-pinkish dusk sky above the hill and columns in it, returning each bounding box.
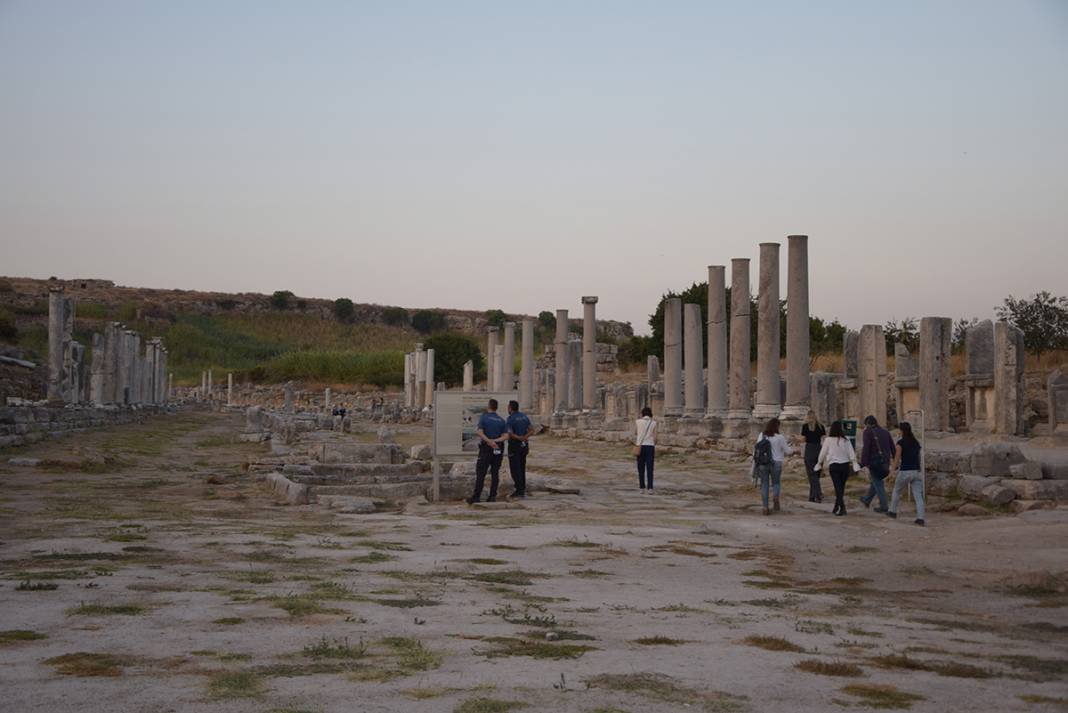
[0,0,1068,331]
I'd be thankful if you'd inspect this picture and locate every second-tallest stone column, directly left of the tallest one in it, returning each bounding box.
[753,242,783,421]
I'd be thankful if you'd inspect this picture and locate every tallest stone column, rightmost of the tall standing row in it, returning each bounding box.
[783,235,812,418]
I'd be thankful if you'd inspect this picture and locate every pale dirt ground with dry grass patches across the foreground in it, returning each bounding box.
[0,413,1068,713]
